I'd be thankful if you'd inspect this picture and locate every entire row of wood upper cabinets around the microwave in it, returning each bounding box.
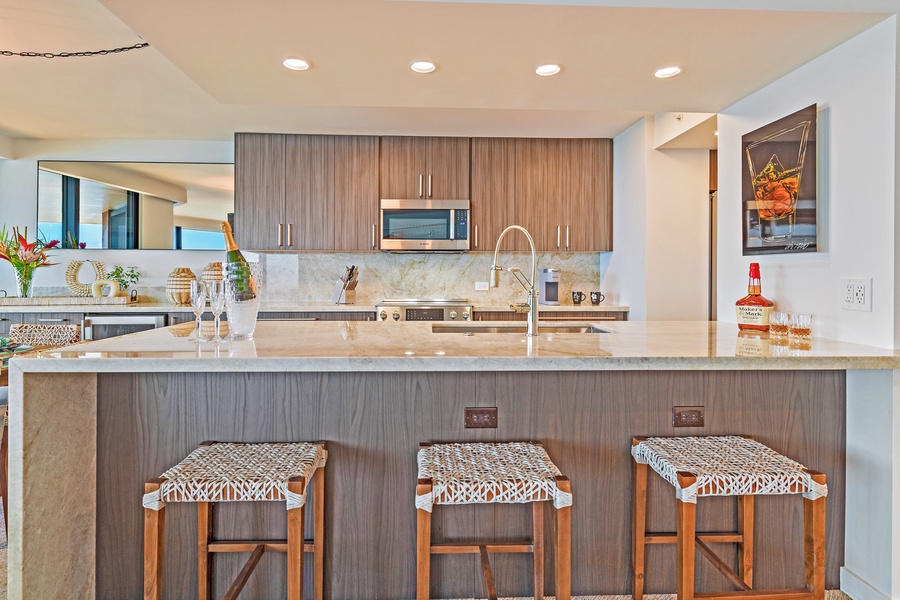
[235,133,612,251]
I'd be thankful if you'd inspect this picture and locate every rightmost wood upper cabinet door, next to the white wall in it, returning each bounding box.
[561,139,612,252]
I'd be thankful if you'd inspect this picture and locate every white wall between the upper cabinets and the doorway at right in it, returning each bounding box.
[603,119,709,321]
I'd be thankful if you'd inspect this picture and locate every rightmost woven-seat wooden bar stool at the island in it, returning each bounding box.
[631,436,828,600]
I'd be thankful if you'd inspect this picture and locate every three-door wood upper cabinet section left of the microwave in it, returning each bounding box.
[235,134,378,250]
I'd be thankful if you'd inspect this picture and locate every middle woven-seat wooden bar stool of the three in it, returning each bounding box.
[416,442,572,600]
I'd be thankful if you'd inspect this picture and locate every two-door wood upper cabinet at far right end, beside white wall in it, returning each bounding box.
[516,139,612,252]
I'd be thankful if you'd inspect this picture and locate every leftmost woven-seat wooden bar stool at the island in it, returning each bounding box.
[142,442,328,600]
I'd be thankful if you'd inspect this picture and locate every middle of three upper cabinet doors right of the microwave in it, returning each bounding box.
[504,139,564,251]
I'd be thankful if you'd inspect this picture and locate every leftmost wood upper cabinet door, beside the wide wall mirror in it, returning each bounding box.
[234,133,286,250]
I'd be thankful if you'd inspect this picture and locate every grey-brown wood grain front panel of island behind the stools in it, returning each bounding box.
[97,371,845,600]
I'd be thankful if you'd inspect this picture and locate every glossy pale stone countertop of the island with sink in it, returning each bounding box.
[10,321,900,378]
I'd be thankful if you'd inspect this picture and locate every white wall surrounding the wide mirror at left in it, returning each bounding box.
[0,140,234,294]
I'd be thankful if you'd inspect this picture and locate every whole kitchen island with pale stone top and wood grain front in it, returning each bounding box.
[9,321,900,599]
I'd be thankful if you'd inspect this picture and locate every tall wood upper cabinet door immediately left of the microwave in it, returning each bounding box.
[334,135,378,251]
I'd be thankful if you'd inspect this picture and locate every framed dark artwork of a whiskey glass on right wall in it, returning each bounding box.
[741,104,817,256]
